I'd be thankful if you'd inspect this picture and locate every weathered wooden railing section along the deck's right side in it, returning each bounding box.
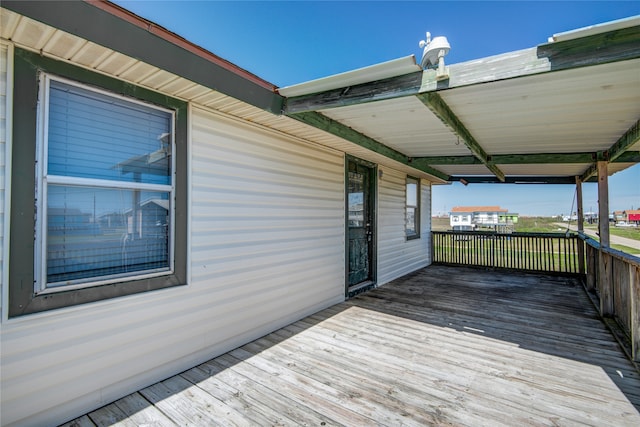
[580,235,640,362]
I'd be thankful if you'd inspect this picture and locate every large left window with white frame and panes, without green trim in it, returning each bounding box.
[36,74,175,293]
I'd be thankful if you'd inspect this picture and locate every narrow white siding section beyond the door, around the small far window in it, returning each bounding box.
[378,167,431,285]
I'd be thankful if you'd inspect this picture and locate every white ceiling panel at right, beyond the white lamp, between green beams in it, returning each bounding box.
[440,59,640,154]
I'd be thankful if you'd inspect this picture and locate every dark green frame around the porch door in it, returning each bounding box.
[344,154,378,299]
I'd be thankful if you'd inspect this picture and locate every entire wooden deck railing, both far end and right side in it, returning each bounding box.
[431,231,640,362]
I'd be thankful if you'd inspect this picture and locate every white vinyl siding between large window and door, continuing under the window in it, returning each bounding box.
[0,105,345,425]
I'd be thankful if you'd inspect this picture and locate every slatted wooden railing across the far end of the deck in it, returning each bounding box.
[431,231,582,274]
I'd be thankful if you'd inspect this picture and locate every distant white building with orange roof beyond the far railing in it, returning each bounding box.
[449,206,518,231]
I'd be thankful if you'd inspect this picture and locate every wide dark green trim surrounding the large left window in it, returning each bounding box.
[8,47,188,317]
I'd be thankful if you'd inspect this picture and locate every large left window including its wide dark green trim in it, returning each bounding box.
[9,49,188,317]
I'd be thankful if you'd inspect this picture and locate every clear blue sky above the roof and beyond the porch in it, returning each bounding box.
[116,0,640,215]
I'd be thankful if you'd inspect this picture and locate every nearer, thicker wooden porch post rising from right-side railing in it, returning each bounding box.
[596,160,614,316]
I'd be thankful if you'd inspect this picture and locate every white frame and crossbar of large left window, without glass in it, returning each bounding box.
[34,73,176,294]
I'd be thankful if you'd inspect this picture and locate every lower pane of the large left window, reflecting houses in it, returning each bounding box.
[46,185,170,287]
